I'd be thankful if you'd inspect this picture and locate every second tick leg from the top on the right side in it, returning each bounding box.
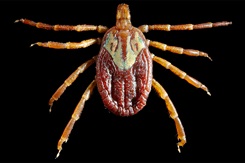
[148,40,212,61]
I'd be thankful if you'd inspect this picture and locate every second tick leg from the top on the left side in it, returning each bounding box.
[31,38,101,49]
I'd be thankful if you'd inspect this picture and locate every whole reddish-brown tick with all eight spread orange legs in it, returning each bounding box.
[15,4,232,158]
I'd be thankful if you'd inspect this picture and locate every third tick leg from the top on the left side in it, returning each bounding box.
[49,57,96,112]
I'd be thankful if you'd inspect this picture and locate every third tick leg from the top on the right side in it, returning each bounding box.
[153,55,211,96]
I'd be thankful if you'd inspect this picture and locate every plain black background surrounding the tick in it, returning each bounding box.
[1,1,244,162]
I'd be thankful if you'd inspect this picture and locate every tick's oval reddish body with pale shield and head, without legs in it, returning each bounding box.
[96,5,152,116]
